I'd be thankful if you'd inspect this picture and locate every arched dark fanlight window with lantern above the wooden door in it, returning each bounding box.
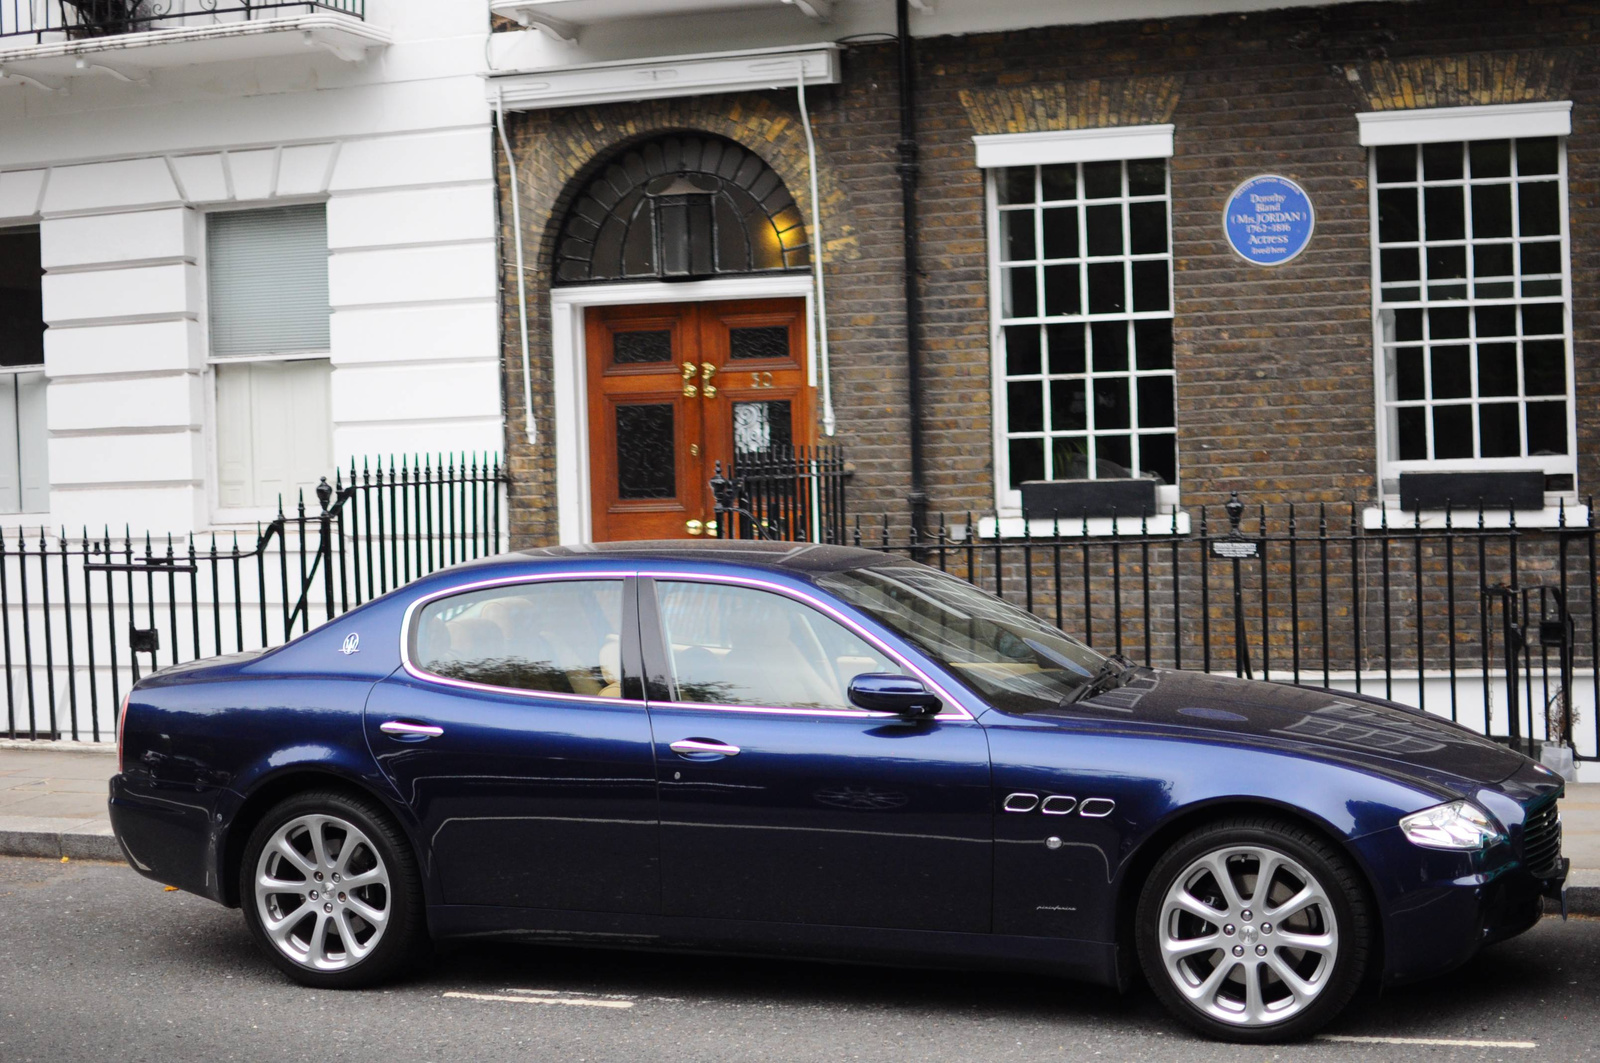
[555,136,811,285]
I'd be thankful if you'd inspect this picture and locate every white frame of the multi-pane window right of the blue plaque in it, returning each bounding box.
[1355,101,1578,496]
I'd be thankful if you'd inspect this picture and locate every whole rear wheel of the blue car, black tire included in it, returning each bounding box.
[238,789,429,989]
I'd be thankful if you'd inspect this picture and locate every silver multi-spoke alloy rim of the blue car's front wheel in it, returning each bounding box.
[1158,845,1339,1026]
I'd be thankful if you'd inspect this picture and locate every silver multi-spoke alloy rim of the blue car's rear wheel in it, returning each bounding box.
[256,815,392,970]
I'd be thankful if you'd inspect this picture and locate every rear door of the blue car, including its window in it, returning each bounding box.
[366,576,661,914]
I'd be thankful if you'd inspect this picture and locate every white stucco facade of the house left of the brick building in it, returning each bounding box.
[0,0,502,533]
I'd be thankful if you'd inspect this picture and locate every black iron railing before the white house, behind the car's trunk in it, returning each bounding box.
[0,456,507,741]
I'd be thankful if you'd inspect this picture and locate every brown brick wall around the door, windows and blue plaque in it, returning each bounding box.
[502,0,1600,541]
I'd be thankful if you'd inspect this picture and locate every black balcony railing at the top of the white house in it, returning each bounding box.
[0,0,366,43]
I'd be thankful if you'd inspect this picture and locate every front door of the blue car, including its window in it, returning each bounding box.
[640,578,994,933]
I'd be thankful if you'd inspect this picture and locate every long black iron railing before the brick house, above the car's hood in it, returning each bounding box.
[857,496,1600,759]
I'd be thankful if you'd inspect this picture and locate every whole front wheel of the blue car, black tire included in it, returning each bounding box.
[1134,816,1373,1044]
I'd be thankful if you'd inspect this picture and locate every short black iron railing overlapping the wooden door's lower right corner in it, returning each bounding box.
[710,447,851,543]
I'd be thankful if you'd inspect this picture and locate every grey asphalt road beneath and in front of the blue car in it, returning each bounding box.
[0,858,1600,1063]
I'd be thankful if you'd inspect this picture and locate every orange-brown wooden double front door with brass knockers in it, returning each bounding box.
[586,299,816,543]
